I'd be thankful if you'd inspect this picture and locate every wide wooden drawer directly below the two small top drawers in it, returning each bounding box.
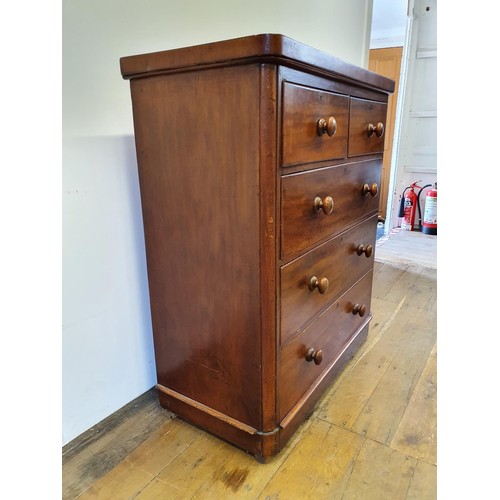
[281,160,382,259]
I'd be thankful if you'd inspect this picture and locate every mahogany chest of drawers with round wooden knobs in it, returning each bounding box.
[120,34,394,458]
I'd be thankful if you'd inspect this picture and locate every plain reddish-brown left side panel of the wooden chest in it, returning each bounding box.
[131,65,261,428]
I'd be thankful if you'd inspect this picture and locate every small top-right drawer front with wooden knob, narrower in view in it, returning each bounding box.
[349,97,387,156]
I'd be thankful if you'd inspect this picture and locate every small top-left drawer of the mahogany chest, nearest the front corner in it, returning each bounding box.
[282,82,349,166]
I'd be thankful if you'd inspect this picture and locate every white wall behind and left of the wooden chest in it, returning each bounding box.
[62,0,372,444]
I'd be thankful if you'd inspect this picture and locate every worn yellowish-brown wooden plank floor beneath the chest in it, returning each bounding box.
[63,232,437,500]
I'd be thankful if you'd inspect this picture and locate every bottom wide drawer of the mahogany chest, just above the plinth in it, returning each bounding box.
[278,271,373,421]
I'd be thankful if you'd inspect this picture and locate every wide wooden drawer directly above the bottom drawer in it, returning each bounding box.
[280,215,377,344]
